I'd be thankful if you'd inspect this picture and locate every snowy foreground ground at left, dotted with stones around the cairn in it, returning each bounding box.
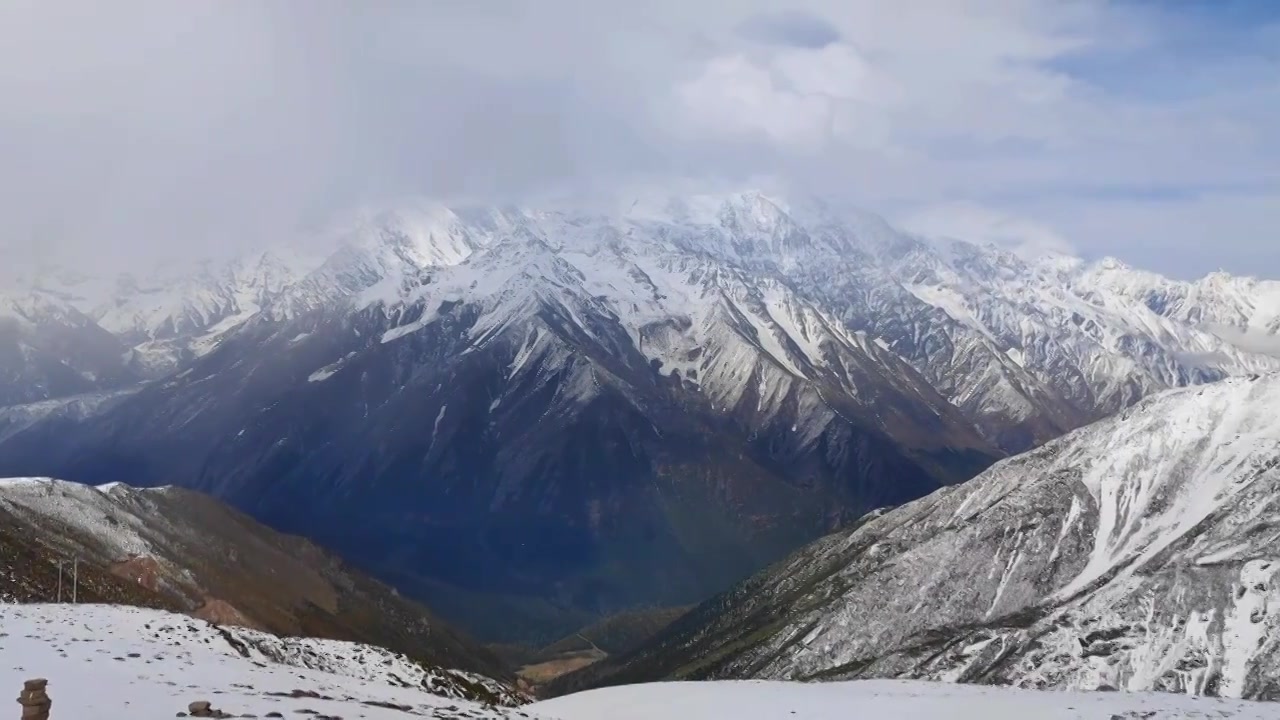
[0,603,535,720]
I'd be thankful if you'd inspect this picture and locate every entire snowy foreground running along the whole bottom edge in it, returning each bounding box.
[0,605,1280,720]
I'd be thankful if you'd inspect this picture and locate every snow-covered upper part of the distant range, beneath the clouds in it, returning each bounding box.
[10,192,1280,450]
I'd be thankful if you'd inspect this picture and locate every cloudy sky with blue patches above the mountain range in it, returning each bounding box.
[0,0,1280,278]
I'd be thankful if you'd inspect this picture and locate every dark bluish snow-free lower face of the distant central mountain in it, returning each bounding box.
[4,283,993,641]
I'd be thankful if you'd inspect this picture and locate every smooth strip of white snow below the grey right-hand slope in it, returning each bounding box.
[529,680,1280,720]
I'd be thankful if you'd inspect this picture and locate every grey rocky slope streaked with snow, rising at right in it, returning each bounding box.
[561,374,1280,700]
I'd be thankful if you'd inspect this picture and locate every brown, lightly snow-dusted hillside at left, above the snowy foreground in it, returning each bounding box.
[0,478,506,678]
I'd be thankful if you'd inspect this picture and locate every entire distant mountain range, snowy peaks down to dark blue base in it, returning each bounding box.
[0,192,1280,639]
